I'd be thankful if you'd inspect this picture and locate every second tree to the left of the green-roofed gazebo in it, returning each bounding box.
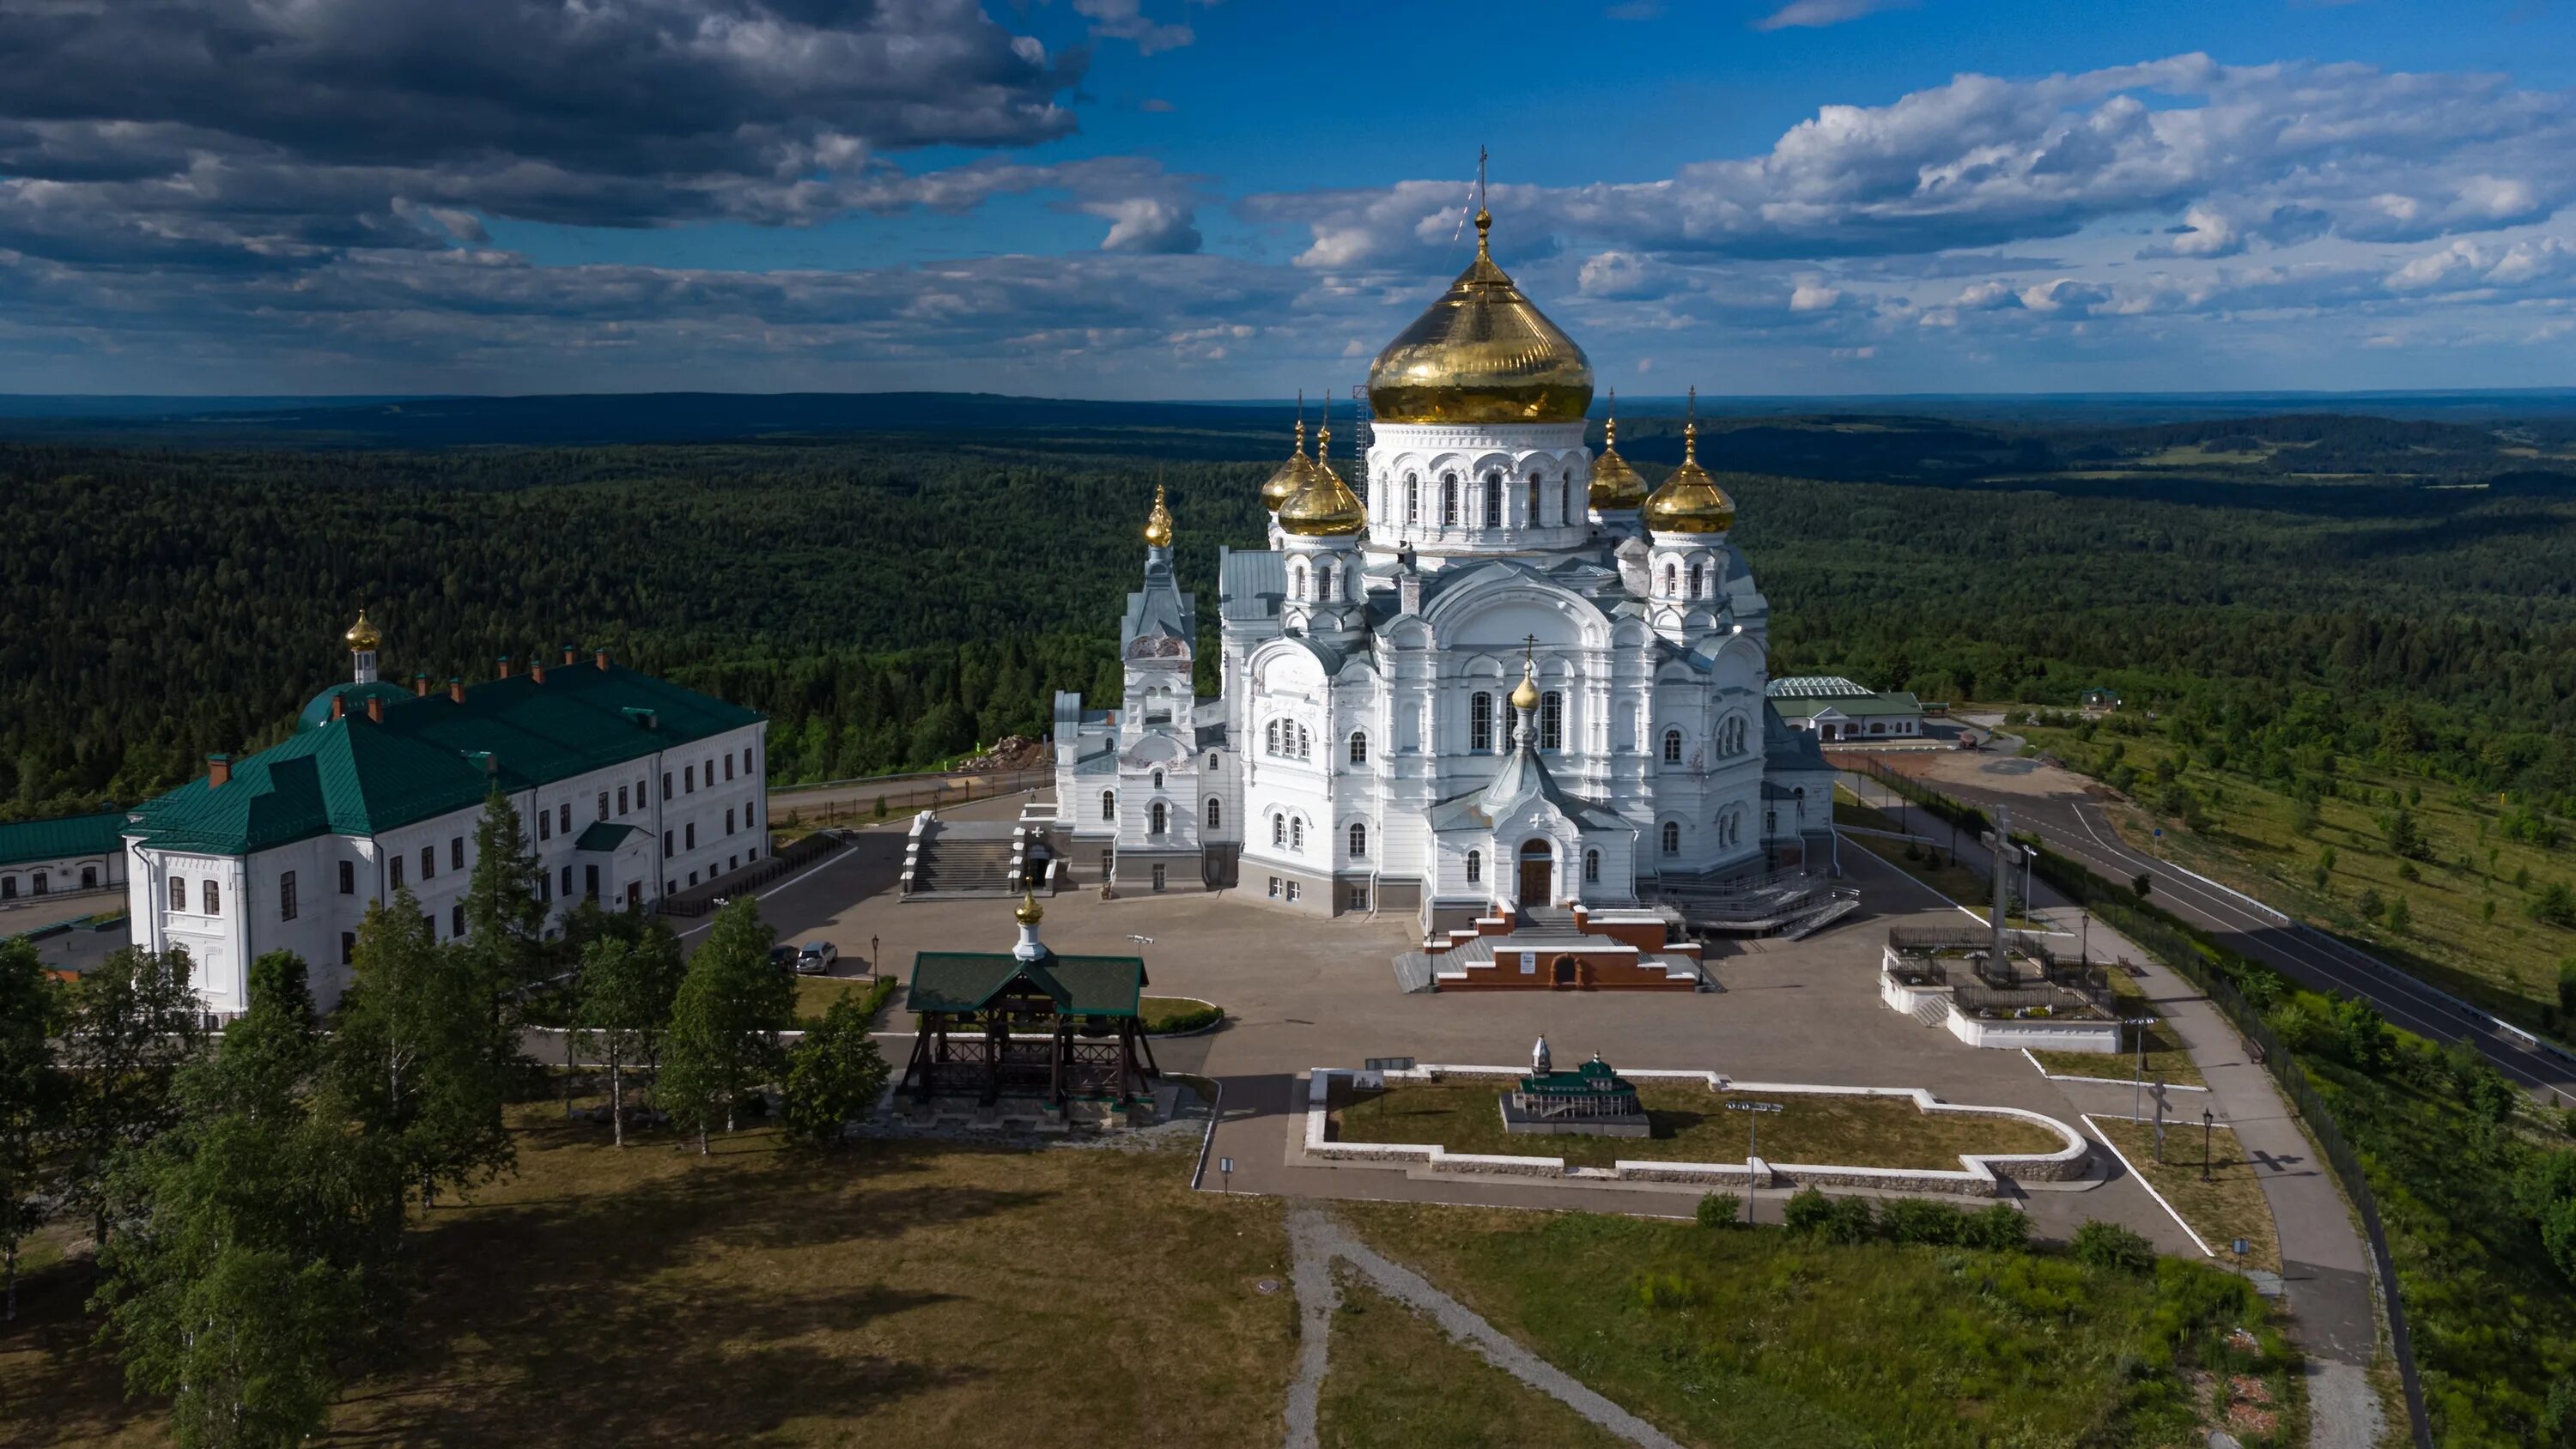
[654,895,796,1153]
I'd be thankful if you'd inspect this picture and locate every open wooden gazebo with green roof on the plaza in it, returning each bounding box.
[902,947,1162,1109]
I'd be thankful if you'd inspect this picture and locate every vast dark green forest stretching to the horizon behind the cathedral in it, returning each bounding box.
[0,412,2576,813]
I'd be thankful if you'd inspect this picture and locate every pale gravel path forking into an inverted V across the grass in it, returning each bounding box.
[1288,1202,1682,1449]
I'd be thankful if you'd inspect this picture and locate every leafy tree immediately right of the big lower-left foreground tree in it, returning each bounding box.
[332,890,518,1204]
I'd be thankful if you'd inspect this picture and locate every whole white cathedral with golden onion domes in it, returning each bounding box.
[1054,211,1834,931]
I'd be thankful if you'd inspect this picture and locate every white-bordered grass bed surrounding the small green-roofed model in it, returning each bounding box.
[1332,1076,2061,1171]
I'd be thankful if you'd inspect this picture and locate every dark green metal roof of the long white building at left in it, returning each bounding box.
[131,664,762,854]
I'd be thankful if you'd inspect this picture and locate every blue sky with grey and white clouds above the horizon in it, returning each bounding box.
[0,0,2576,397]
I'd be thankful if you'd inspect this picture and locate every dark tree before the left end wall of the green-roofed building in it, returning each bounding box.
[59,947,206,1243]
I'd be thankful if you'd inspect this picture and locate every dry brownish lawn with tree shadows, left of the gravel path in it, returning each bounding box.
[0,1101,1296,1446]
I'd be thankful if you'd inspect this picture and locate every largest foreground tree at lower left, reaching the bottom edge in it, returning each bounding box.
[98,952,402,1446]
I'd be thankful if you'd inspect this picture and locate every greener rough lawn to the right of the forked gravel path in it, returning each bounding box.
[1324,1202,2303,1449]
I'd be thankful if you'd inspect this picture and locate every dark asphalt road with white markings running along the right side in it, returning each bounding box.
[1847,764,2576,1106]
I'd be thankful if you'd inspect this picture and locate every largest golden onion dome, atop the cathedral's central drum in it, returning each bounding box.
[1368,209,1592,422]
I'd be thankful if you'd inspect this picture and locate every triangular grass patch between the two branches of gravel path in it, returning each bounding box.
[1316,1271,1620,1449]
